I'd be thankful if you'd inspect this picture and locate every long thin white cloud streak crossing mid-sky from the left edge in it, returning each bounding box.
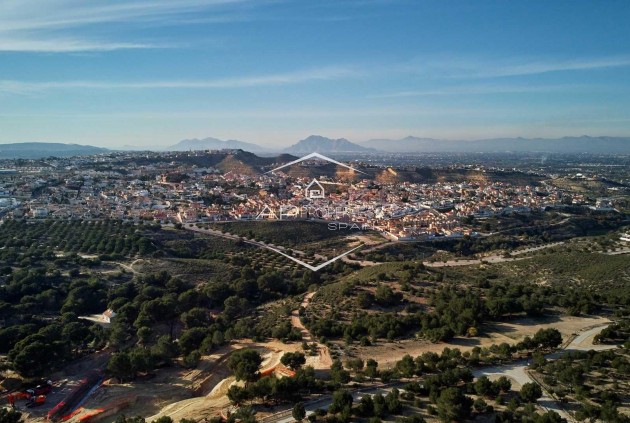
[0,66,361,94]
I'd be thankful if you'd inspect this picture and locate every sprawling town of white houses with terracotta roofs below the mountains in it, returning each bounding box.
[0,150,623,241]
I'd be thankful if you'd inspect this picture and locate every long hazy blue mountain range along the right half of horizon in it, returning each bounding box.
[361,135,630,154]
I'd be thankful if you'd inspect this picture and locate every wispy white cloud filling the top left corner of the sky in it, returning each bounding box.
[0,0,260,53]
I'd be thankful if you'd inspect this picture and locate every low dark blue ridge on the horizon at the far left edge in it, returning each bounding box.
[0,142,110,159]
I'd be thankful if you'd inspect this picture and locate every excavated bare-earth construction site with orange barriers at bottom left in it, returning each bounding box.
[3,341,332,422]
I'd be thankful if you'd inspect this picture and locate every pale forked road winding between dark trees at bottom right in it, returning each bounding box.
[473,323,617,422]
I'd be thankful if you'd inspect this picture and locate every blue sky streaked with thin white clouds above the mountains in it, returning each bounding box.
[0,0,630,148]
